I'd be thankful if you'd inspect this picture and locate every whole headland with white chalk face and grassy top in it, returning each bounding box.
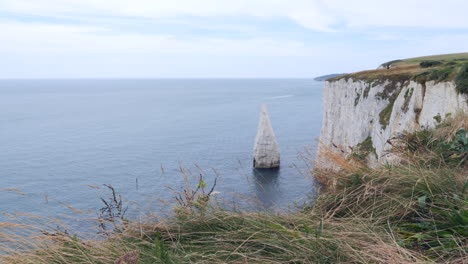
[316,53,468,168]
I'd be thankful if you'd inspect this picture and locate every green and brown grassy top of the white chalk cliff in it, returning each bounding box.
[328,53,468,94]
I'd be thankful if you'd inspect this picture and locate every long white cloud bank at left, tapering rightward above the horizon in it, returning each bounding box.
[0,23,330,56]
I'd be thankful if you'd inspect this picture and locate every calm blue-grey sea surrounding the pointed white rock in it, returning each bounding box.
[0,79,323,222]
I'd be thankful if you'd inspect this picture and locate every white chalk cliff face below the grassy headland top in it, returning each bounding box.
[318,78,468,166]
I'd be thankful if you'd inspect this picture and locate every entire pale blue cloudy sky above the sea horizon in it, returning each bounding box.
[0,0,468,78]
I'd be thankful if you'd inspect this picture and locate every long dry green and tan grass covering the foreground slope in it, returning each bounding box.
[0,114,468,264]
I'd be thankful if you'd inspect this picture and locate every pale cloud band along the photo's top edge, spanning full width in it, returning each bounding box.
[0,0,468,31]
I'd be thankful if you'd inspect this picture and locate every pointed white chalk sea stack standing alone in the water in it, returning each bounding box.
[253,105,280,169]
